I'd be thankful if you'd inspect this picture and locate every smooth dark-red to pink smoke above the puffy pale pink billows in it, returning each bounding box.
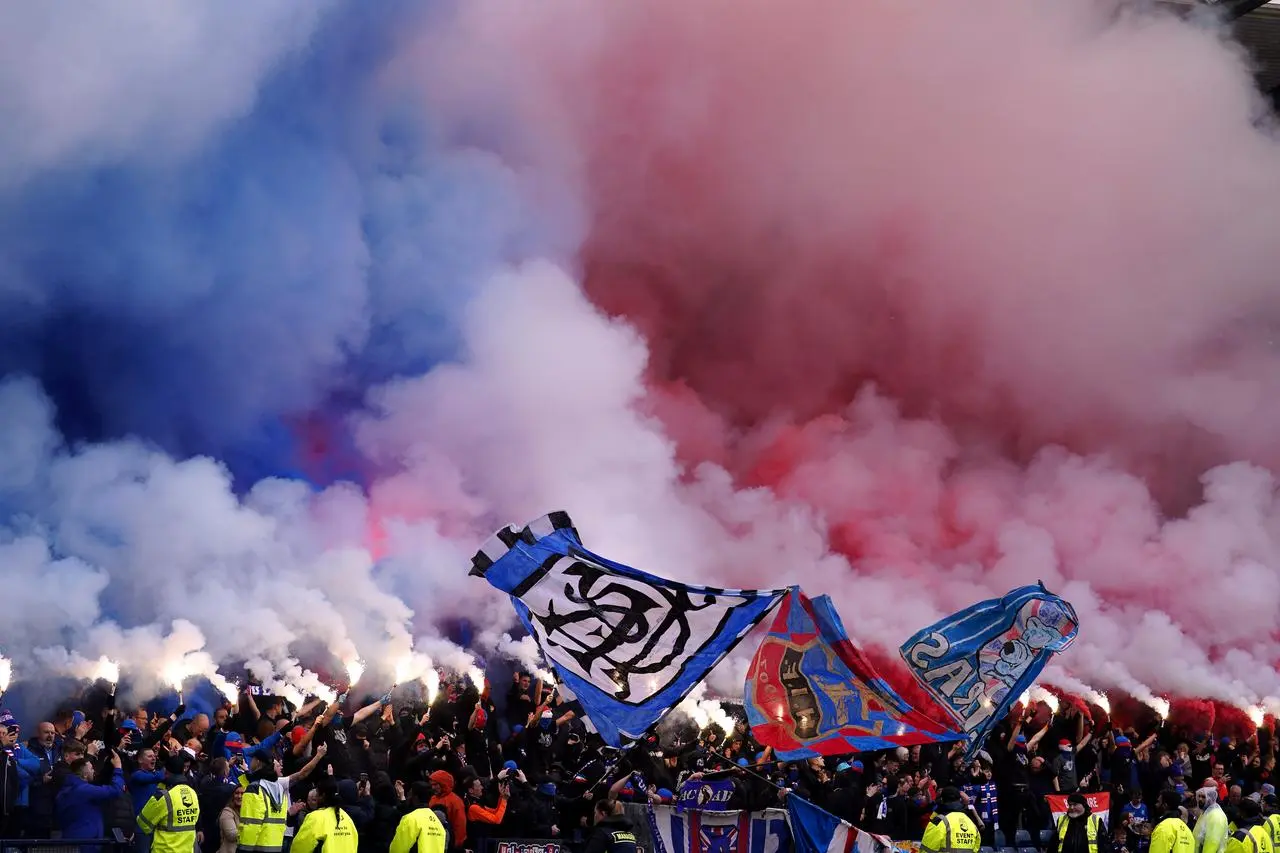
[465,0,1280,487]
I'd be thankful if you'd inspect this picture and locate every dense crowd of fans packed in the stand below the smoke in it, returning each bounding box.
[0,672,1275,853]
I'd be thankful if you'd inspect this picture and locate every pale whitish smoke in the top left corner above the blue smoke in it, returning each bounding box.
[0,0,337,188]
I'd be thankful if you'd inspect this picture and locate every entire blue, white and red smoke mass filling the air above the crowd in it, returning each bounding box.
[0,0,1280,703]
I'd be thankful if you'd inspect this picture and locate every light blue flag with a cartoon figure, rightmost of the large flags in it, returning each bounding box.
[900,584,1079,753]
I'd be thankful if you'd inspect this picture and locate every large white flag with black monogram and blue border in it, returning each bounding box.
[471,512,787,747]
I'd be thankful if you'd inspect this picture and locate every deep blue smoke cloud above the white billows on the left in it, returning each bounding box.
[0,3,576,487]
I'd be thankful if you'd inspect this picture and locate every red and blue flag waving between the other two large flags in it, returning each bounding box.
[744,589,964,761]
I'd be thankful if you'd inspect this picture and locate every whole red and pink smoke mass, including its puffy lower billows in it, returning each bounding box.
[436,0,1280,706]
